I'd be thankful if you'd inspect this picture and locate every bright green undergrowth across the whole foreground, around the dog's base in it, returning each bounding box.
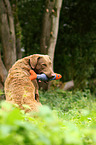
[0,90,96,145]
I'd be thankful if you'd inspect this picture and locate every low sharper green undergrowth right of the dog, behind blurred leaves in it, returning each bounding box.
[40,89,91,112]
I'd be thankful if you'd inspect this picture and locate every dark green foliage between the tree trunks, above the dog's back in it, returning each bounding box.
[18,0,45,56]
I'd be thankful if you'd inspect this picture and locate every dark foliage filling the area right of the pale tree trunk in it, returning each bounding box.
[54,0,96,91]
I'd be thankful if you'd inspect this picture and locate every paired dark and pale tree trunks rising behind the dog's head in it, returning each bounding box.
[41,0,62,67]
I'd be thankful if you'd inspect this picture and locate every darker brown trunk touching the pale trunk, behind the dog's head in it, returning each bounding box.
[40,0,54,54]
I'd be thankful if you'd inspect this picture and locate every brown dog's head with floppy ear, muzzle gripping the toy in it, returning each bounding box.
[30,54,54,78]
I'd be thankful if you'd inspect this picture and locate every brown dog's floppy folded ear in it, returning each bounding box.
[30,55,42,69]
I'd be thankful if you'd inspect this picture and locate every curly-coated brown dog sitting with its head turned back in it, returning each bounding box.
[5,54,54,112]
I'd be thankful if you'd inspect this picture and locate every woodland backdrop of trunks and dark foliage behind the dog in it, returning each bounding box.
[0,0,96,93]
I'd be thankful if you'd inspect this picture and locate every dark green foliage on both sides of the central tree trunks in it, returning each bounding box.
[12,0,96,92]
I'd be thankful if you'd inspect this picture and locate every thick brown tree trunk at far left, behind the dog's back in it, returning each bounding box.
[0,0,16,70]
